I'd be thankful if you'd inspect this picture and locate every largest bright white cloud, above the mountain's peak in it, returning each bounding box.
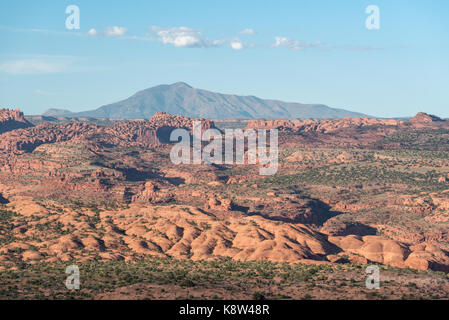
[151,26,209,48]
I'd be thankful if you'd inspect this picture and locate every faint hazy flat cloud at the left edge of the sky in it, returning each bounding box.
[0,57,72,74]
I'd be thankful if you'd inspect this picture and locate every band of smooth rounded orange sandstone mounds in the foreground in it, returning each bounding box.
[0,201,449,272]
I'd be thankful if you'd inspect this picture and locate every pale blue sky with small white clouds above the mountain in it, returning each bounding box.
[0,0,449,117]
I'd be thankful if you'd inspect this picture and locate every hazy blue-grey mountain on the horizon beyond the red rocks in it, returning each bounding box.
[43,82,370,119]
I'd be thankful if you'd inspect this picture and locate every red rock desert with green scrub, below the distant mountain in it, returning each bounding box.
[0,102,449,299]
